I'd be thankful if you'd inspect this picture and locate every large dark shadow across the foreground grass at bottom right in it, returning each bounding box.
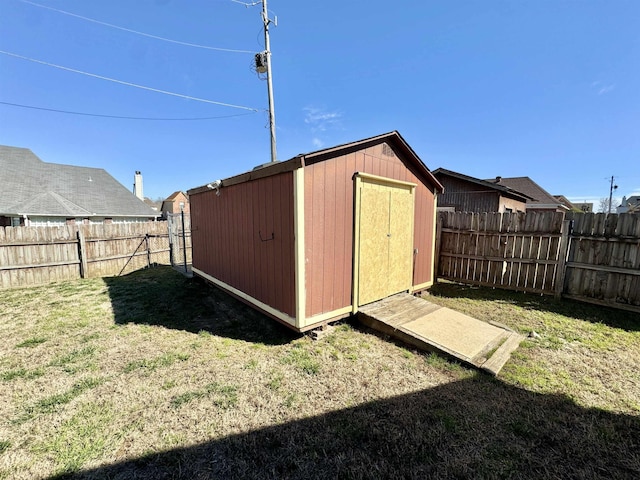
[54,375,640,480]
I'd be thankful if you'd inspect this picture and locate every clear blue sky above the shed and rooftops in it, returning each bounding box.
[0,0,640,206]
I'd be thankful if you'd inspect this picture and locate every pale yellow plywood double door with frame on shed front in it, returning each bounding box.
[354,174,415,305]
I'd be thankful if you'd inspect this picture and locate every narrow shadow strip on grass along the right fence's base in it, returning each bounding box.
[429,282,640,332]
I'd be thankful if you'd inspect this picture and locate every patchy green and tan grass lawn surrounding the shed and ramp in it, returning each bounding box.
[0,267,640,479]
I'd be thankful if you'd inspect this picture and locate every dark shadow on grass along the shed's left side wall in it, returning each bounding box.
[104,266,296,345]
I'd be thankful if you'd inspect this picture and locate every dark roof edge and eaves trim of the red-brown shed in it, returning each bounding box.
[188,130,444,195]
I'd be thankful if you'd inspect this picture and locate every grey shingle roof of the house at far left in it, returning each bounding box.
[0,145,157,218]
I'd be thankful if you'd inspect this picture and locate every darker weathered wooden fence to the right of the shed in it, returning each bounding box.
[436,212,640,312]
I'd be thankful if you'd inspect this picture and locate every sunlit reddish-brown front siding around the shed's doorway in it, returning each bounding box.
[304,143,435,317]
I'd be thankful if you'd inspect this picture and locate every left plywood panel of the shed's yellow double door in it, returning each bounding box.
[358,188,390,304]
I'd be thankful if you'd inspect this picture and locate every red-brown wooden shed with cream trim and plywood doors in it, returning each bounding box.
[188,131,443,332]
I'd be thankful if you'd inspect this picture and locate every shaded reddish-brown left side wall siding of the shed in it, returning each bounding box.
[190,172,295,317]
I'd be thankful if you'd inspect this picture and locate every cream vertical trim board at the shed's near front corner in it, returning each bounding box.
[293,166,307,329]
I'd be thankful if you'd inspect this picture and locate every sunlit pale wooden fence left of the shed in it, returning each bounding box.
[0,222,175,288]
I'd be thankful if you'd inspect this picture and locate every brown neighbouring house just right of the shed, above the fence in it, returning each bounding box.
[432,168,530,213]
